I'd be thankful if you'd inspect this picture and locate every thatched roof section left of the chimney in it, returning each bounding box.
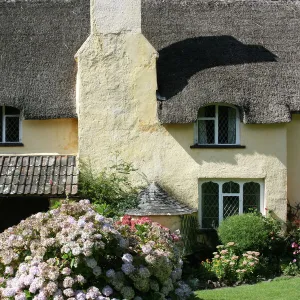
[0,0,90,119]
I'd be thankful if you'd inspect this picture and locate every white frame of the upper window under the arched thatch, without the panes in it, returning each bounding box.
[194,104,241,146]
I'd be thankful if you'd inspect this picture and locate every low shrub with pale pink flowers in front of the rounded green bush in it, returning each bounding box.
[202,242,260,285]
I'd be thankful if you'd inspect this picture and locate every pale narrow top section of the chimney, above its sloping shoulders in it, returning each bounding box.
[91,0,141,34]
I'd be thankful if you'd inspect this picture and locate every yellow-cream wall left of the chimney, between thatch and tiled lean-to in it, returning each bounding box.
[0,119,78,155]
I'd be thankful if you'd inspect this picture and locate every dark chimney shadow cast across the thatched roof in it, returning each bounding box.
[157,35,277,99]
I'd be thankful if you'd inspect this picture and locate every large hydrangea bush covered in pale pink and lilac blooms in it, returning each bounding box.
[0,200,191,300]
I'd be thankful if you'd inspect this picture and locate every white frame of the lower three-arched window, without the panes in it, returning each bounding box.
[198,178,266,228]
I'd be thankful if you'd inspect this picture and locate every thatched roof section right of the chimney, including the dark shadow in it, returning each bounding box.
[142,0,300,123]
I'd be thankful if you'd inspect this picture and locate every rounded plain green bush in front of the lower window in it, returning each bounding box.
[218,213,278,253]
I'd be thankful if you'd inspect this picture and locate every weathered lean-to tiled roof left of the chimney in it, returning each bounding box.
[0,155,78,196]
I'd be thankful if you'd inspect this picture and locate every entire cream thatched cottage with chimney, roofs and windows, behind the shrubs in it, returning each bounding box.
[0,0,300,228]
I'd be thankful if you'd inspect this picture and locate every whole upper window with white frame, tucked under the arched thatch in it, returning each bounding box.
[195,104,239,145]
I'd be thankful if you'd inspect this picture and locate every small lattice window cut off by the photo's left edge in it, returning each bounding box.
[0,106,21,143]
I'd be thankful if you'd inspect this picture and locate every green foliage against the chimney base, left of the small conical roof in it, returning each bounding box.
[79,158,140,217]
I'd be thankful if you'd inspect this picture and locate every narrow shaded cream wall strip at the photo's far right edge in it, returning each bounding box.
[287,114,300,206]
